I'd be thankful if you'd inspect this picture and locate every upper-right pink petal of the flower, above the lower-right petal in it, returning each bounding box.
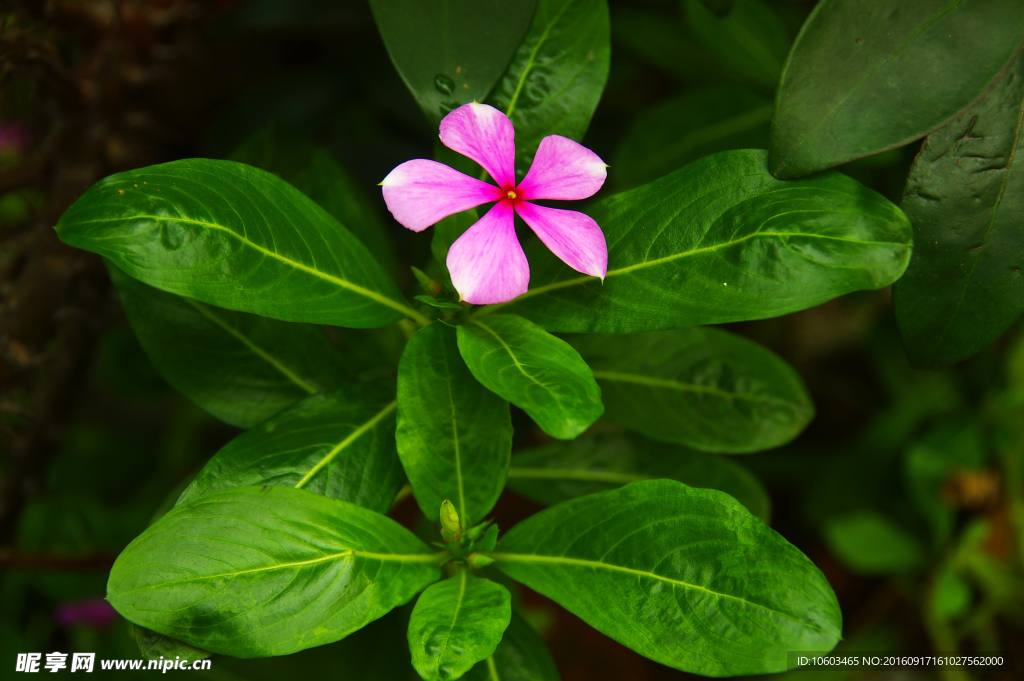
[516,135,608,201]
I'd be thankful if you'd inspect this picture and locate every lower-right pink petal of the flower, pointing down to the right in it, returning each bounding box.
[515,201,608,280]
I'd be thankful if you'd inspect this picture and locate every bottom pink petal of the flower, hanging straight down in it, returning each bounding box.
[446,200,529,305]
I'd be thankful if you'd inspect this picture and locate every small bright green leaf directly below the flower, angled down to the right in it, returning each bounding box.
[458,314,604,439]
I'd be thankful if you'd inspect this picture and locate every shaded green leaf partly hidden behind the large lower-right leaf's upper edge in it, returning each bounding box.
[508,435,771,522]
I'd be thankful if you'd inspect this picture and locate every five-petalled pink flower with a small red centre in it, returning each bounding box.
[381,102,608,305]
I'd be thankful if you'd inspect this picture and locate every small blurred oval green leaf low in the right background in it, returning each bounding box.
[824,510,927,574]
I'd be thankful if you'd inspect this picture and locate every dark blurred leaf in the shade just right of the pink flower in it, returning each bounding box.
[609,86,772,188]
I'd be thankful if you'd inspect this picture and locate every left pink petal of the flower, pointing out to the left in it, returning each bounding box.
[381,159,504,231]
